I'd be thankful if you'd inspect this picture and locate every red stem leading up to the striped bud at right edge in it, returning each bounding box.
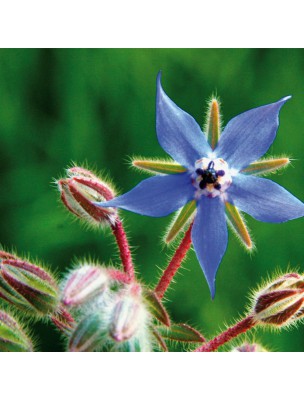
[194,315,257,352]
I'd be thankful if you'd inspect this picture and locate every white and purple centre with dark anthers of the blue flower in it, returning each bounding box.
[193,157,232,198]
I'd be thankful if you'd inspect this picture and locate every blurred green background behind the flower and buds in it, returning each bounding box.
[0,49,304,351]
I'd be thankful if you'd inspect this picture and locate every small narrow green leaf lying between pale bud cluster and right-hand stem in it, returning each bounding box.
[158,324,206,343]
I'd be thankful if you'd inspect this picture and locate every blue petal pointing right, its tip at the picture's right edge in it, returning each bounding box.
[227,174,304,223]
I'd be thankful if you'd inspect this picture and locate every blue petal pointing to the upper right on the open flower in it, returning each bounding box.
[215,96,290,171]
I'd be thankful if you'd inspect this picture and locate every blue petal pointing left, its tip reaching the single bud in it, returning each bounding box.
[96,172,195,217]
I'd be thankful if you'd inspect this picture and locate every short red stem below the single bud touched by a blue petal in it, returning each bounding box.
[111,217,134,280]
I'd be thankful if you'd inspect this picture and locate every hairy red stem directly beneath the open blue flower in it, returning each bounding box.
[155,224,192,299]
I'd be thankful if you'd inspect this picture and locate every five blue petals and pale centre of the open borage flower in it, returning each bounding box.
[97,73,304,297]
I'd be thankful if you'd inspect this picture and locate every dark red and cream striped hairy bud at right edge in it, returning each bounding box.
[253,273,304,327]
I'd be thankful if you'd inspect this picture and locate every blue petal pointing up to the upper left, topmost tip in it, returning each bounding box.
[156,73,212,168]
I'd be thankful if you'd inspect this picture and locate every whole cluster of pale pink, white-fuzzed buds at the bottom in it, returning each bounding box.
[62,264,151,352]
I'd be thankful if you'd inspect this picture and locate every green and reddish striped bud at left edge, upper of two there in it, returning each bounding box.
[0,257,58,315]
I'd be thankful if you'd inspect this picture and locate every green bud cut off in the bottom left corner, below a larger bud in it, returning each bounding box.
[0,310,33,352]
